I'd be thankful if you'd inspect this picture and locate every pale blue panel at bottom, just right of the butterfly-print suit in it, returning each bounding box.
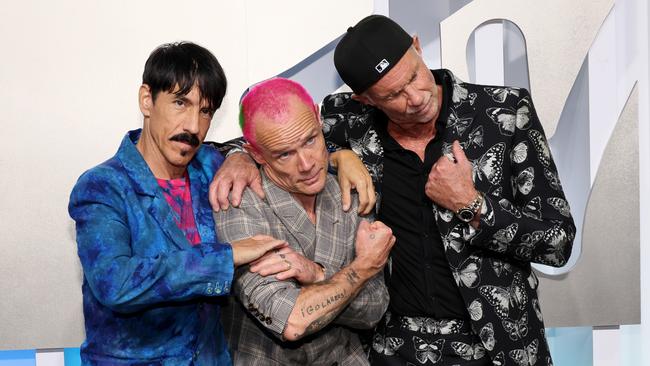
[546,327,594,366]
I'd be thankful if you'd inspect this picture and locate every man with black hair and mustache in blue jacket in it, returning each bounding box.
[68,42,287,365]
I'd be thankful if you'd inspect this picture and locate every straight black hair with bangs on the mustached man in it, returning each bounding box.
[142,42,227,111]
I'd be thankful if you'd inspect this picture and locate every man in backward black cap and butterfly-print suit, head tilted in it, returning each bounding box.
[213,15,575,366]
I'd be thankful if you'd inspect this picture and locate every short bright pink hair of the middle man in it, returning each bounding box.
[239,78,318,149]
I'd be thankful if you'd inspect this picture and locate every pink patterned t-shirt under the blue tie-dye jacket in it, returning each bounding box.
[156,172,201,245]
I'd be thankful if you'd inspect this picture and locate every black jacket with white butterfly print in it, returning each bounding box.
[321,70,575,365]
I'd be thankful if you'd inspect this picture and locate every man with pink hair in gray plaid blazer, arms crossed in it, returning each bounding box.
[215,78,395,366]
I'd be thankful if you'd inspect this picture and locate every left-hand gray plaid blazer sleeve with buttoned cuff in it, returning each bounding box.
[215,188,300,339]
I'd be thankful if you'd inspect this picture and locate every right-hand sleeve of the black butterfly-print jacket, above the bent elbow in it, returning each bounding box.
[469,89,576,267]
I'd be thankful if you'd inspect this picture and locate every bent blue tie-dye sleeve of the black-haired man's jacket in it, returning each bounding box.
[68,170,234,313]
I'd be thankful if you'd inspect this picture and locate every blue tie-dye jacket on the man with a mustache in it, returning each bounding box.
[68,130,234,365]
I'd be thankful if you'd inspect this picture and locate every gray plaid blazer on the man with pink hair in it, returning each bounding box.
[215,170,388,366]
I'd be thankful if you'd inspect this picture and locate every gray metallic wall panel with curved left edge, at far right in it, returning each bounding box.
[539,87,641,327]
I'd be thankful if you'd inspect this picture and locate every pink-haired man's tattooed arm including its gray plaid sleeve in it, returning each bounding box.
[215,189,395,340]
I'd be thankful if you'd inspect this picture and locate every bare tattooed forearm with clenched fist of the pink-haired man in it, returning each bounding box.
[282,221,395,341]
